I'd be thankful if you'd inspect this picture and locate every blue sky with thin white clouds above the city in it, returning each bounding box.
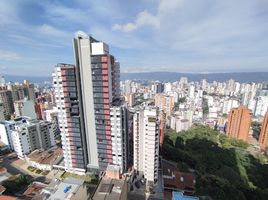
[0,0,268,76]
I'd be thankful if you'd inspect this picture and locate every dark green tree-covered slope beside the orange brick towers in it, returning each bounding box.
[161,126,268,200]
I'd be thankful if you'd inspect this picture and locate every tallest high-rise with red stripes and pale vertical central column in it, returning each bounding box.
[53,32,120,172]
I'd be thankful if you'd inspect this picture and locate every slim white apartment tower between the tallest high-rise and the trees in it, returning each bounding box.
[133,107,159,183]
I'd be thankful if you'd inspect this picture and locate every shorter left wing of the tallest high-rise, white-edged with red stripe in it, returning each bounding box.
[53,64,85,172]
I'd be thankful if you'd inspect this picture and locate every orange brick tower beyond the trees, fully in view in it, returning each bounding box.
[227,106,252,141]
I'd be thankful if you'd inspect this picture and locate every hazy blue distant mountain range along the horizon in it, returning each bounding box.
[5,72,268,83]
